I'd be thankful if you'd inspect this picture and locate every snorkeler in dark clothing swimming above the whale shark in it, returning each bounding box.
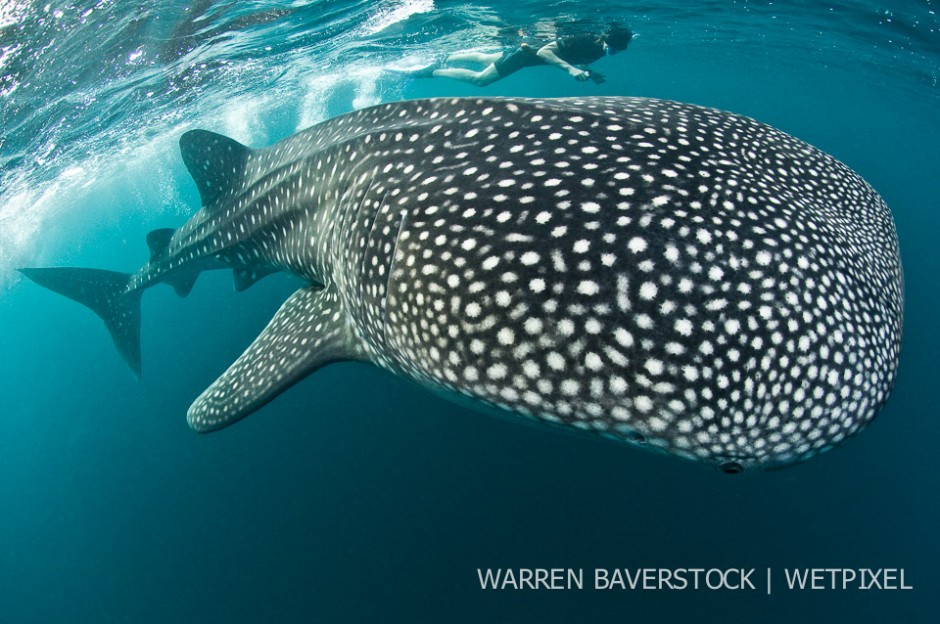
[406,24,633,87]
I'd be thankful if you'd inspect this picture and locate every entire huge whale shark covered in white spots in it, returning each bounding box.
[21,97,903,472]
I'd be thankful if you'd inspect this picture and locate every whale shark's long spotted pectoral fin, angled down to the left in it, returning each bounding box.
[186,286,367,433]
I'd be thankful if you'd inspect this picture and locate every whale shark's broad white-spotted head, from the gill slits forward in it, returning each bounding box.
[352,98,902,472]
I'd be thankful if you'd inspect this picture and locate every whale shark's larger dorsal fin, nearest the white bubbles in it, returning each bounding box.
[180,130,251,206]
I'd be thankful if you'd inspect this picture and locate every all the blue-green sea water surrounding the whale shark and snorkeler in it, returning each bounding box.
[0,0,940,624]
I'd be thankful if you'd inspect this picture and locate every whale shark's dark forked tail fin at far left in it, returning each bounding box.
[19,267,142,377]
